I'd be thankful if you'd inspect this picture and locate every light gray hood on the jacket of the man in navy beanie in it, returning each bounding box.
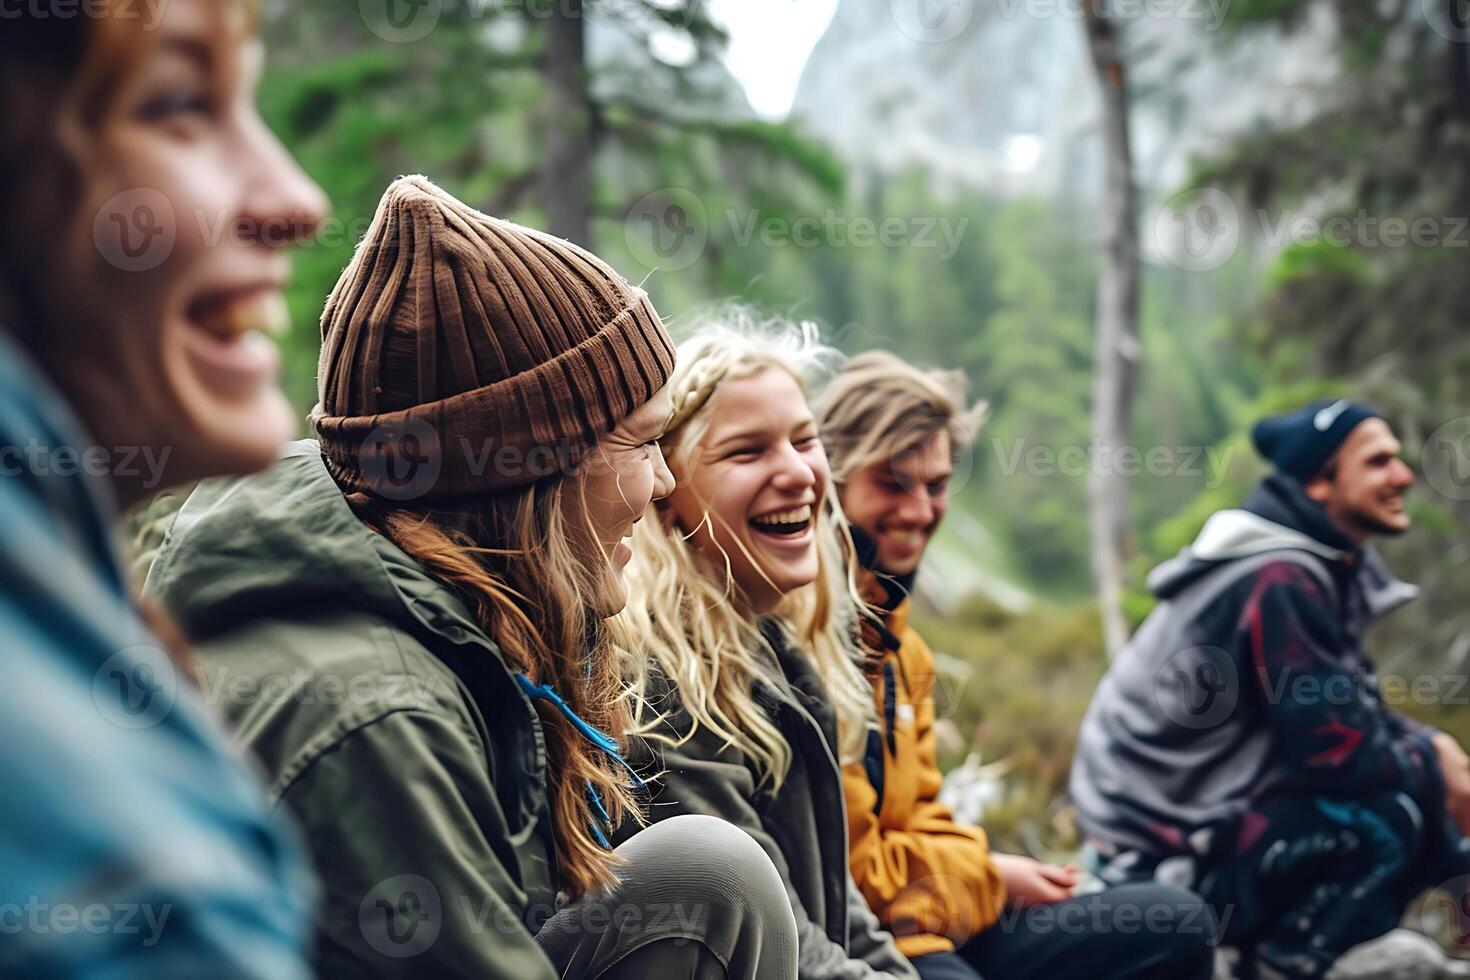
[1148,473,1419,619]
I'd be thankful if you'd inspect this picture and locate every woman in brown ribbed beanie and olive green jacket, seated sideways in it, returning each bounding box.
[148,176,795,980]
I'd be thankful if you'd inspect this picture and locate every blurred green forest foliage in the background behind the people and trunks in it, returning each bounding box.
[252,0,1470,846]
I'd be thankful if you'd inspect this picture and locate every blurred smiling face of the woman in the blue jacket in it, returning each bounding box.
[19,0,326,502]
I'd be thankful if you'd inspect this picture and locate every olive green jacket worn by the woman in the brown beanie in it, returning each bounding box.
[147,442,557,980]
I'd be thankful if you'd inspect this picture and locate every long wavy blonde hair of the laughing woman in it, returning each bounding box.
[617,307,872,788]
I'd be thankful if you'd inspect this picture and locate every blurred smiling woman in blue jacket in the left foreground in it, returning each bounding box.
[0,0,326,980]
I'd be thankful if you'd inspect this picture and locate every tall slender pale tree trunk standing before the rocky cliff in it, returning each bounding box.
[1083,0,1139,658]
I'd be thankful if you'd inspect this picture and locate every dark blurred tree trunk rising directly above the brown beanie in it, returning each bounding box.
[539,0,595,248]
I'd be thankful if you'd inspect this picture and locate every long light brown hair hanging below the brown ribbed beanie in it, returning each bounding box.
[347,478,642,895]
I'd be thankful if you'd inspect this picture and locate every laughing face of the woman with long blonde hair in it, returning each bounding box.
[669,367,832,611]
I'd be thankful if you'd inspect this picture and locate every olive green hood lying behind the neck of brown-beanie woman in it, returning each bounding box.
[144,439,488,644]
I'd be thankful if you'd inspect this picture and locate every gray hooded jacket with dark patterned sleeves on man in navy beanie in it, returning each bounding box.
[1070,475,1442,857]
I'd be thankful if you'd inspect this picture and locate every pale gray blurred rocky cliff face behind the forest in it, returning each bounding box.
[792,0,1336,197]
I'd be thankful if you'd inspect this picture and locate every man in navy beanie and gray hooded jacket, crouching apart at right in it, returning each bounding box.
[1070,400,1470,977]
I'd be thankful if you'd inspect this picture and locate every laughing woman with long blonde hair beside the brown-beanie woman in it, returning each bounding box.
[622,311,914,980]
